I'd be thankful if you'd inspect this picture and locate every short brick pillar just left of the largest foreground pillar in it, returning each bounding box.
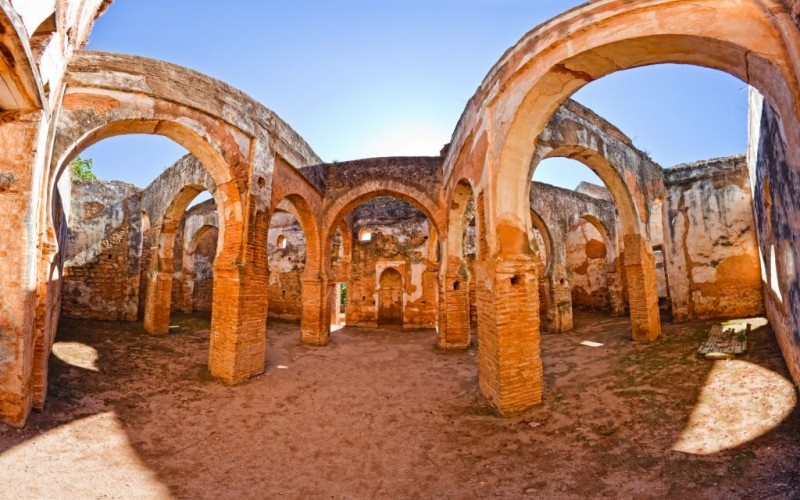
[438,259,470,350]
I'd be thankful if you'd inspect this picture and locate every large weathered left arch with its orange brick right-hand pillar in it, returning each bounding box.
[49,52,319,390]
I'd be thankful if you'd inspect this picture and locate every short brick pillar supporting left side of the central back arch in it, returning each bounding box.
[300,277,335,347]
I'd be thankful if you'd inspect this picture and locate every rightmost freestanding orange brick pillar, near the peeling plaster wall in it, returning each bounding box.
[624,234,661,342]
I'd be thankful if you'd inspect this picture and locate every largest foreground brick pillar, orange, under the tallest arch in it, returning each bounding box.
[478,255,543,415]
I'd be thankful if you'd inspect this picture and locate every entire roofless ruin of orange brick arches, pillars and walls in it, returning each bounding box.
[0,0,800,426]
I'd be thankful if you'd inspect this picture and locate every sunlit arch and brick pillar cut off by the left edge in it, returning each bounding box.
[0,2,115,425]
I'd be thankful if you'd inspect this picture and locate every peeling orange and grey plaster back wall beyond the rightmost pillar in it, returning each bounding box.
[664,156,764,321]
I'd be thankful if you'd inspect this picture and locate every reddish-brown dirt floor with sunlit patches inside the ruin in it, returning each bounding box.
[0,313,800,499]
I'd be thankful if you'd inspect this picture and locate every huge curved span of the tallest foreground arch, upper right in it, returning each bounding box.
[446,0,798,234]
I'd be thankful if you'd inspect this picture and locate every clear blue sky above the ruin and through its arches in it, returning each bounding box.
[83,0,747,188]
